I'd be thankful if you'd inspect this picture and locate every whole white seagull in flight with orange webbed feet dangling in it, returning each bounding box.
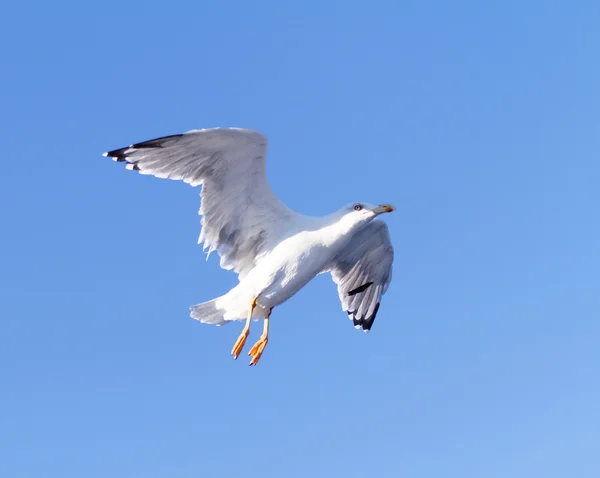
[104,128,394,365]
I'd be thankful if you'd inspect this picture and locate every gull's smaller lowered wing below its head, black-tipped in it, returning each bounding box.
[329,220,394,332]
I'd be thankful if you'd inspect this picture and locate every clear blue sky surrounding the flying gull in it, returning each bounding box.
[0,0,600,478]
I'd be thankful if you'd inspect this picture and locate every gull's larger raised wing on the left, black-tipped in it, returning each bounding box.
[104,128,296,280]
